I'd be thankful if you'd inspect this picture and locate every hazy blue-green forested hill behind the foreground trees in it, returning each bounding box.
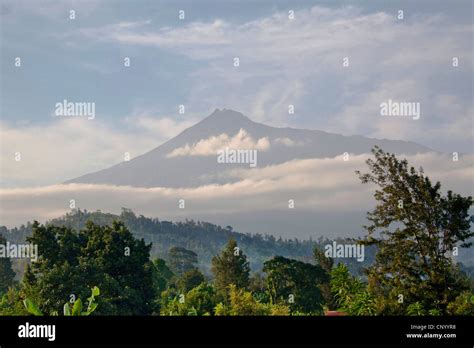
[0,209,374,274]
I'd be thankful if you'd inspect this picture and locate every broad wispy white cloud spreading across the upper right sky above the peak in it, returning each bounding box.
[71,6,473,142]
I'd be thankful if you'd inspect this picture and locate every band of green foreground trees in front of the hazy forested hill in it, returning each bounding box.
[0,222,474,316]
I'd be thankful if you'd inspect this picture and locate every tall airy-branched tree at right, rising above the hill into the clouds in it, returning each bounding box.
[356,147,474,314]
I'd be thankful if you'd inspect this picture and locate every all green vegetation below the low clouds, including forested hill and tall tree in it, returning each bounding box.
[0,148,474,316]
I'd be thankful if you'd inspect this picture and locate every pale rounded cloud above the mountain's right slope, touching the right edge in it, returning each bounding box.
[328,79,474,152]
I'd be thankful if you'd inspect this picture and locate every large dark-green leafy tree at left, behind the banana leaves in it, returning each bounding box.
[23,222,155,315]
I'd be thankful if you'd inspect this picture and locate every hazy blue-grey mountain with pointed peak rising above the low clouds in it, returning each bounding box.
[66,109,431,187]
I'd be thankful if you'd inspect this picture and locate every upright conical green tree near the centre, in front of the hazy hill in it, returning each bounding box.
[211,239,250,293]
